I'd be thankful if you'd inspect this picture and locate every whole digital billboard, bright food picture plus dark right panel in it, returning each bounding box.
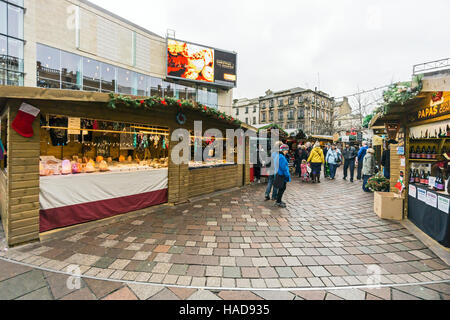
[167,39,237,87]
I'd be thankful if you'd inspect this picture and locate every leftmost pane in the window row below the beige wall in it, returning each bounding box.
[36,44,61,88]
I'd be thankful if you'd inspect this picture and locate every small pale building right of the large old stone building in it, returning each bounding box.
[333,97,362,136]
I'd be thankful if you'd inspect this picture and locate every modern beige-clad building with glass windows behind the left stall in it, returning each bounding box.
[0,0,233,113]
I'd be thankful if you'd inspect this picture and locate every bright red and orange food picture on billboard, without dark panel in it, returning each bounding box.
[167,39,214,82]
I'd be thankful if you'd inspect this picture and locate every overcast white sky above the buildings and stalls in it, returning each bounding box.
[91,0,450,98]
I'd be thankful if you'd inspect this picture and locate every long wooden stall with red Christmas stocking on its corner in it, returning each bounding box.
[0,87,250,245]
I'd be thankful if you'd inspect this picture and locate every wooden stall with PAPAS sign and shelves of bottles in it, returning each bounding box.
[372,91,450,248]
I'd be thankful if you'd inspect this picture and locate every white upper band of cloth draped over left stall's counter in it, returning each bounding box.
[39,168,168,210]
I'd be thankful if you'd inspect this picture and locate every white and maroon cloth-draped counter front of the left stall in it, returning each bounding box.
[39,169,168,232]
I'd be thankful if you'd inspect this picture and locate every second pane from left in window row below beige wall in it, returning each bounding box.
[61,51,82,90]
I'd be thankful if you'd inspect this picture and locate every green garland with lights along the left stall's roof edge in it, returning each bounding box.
[107,93,242,126]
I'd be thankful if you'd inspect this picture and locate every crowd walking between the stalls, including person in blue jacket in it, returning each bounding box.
[265,141,389,208]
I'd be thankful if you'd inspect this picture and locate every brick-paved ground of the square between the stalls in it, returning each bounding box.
[0,170,450,300]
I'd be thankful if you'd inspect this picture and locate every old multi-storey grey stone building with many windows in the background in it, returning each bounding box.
[259,88,334,135]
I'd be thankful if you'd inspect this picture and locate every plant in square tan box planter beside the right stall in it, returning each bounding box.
[367,172,403,220]
